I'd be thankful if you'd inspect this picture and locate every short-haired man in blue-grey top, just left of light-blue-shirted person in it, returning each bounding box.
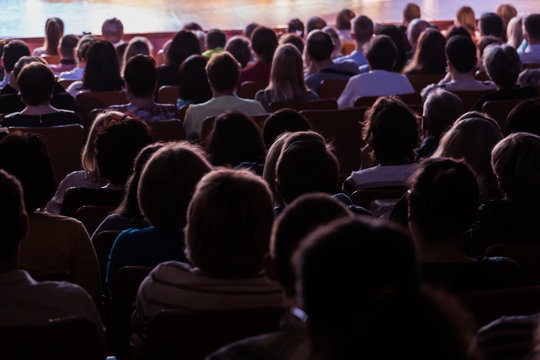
[306,30,359,93]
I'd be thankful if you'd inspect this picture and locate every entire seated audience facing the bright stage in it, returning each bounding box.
[0,3,540,360]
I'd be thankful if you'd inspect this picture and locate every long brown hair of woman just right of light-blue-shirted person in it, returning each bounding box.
[405,29,446,74]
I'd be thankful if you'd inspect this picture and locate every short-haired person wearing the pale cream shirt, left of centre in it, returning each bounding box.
[184,50,265,139]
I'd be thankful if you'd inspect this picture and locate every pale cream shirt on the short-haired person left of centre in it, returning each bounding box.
[184,95,266,139]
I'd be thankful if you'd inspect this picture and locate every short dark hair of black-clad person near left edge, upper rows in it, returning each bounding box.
[17,62,56,106]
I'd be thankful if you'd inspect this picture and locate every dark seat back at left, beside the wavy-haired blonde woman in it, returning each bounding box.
[8,124,85,183]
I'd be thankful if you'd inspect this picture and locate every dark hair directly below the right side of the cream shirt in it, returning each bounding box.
[208,111,266,167]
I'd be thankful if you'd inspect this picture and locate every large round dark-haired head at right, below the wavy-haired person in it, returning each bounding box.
[409,158,479,241]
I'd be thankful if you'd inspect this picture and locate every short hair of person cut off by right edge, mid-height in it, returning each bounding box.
[491,132,540,204]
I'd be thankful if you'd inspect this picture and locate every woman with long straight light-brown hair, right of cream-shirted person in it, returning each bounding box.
[255,44,319,109]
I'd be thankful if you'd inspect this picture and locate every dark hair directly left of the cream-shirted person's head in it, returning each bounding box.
[178,55,212,104]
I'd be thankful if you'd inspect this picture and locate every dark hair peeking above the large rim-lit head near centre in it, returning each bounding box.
[263,109,311,149]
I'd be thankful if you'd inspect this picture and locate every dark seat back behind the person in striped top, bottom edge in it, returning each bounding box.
[148,308,284,360]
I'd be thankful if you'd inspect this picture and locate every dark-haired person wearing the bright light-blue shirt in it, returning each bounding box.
[338,35,414,109]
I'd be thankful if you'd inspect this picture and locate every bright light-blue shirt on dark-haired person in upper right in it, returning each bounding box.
[338,70,414,109]
